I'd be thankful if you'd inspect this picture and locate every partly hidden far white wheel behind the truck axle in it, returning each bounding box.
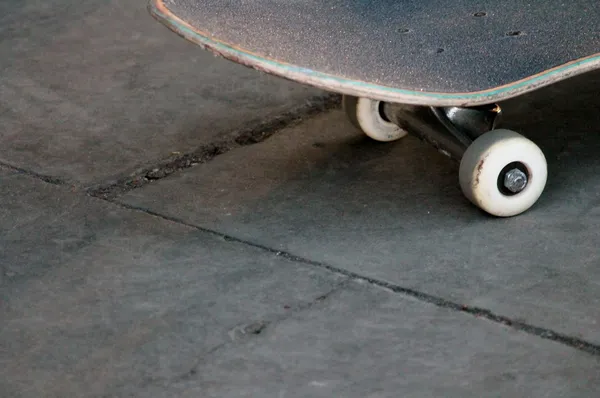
[343,96,407,142]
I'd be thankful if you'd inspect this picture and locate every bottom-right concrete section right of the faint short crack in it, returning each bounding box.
[129,284,600,398]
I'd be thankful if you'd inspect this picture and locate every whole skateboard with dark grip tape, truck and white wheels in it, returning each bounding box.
[148,0,600,217]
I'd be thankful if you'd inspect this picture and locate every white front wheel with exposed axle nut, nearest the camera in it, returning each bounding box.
[459,130,548,217]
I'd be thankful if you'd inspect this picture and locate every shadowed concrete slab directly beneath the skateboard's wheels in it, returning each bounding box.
[121,74,600,343]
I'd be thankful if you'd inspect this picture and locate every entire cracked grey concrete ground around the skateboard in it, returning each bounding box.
[0,0,600,398]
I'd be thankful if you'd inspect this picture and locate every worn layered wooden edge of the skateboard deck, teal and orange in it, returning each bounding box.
[148,0,600,107]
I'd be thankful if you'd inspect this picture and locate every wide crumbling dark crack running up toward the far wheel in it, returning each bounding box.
[86,94,341,200]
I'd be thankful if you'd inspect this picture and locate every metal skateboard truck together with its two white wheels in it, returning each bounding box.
[343,97,547,217]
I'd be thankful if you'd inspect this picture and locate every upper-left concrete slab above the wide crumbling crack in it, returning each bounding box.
[0,0,322,184]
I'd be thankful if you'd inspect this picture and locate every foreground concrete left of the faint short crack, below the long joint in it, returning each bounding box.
[0,171,343,398]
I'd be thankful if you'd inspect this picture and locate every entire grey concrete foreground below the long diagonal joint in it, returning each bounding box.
[0,170,600,398]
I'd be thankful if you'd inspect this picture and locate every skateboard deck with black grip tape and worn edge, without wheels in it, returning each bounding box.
[149,0,600,106]
